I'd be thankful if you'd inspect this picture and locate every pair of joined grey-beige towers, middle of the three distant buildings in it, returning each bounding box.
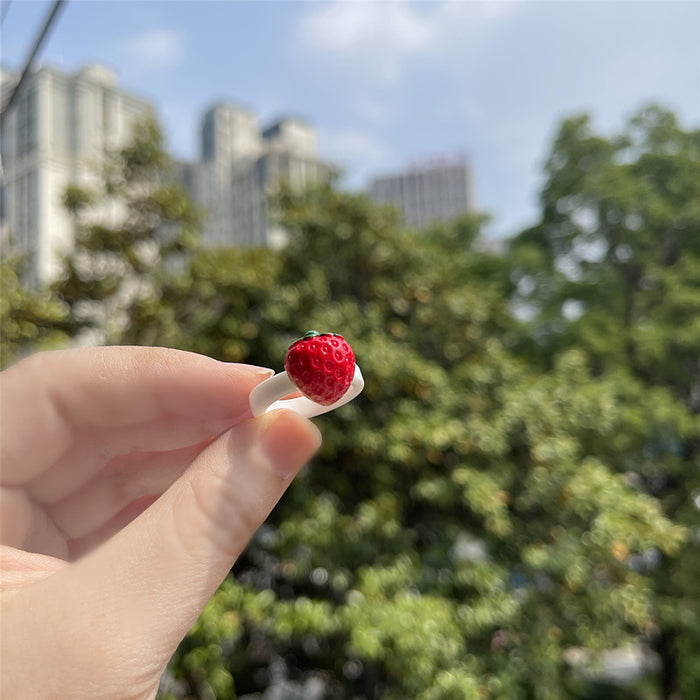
[180,103,330,248]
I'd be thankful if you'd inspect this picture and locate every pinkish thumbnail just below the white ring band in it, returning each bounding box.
[260,410,321,479]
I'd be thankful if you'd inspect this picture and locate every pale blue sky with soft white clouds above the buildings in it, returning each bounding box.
[0,0,700,236]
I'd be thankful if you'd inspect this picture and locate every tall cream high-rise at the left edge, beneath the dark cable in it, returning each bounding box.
[0,65,153,284]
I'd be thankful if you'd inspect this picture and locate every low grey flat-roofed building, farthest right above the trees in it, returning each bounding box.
[370,158,474,228]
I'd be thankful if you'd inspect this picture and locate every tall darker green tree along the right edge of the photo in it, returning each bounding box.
[512,106,700,697]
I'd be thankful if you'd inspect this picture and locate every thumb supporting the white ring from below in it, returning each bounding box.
[8,410,321,688]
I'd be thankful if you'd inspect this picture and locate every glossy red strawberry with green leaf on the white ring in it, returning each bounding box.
[284,331,355,406]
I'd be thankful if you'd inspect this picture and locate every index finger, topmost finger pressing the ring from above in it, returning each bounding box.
[0,347,272,485]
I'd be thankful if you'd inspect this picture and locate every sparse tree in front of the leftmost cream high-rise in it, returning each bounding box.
[54,118,201,343]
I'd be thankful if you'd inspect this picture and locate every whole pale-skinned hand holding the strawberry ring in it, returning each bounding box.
[0,347,321,700]
